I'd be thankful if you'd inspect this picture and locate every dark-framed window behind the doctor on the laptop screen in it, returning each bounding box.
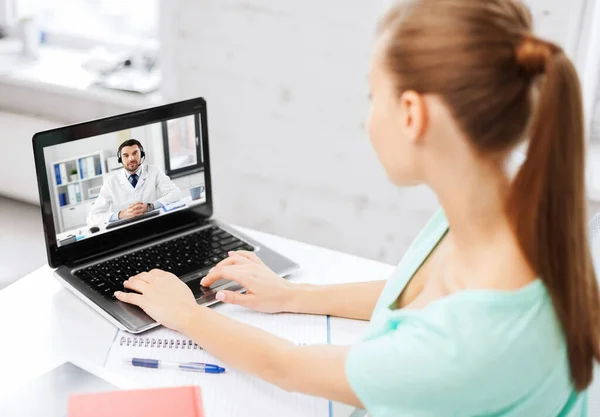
[162,116,204,178]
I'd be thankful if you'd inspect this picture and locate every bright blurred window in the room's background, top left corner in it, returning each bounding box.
[14,0,160,47]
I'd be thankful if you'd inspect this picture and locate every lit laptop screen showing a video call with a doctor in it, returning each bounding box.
[43,114,206,248]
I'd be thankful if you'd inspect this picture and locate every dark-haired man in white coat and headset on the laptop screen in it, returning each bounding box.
[87,139,181,226]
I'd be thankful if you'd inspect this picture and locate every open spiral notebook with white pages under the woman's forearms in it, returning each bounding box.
[106,305,330,417]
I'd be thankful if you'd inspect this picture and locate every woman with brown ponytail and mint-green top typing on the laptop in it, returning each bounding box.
[117,0,600,417]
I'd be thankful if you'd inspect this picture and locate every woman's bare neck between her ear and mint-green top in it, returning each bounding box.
[432,156,534,287]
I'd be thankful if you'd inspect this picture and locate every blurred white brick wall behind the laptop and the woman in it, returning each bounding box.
[161,0,579,262]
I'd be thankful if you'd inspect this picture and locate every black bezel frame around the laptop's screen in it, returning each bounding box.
[32,98,213,268]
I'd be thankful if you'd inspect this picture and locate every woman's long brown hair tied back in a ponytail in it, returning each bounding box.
[380,0,600,391]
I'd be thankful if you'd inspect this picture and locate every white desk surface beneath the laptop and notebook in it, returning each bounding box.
[0,229,393,417]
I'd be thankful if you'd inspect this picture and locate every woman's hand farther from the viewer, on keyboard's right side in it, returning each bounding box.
[201,251,293,313]
